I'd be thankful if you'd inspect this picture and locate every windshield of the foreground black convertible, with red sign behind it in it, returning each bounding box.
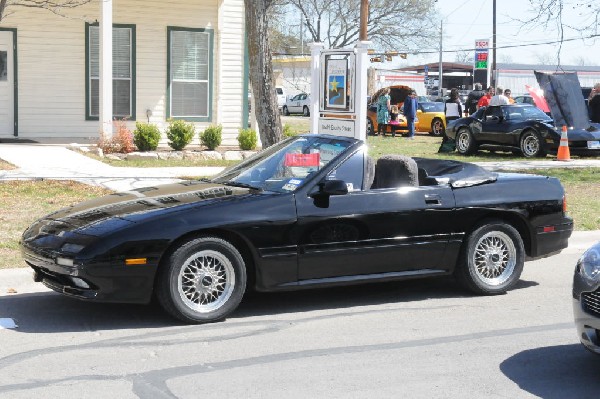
[210,135,355,192]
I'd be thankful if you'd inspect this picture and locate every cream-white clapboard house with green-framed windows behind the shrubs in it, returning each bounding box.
[0,0,248,145]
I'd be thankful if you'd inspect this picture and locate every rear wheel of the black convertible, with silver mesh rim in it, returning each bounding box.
[454,221,525,295]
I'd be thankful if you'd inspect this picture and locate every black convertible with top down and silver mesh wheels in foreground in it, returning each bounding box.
[21,135,573,323]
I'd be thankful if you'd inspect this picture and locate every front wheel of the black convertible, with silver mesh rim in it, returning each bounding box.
[156,237,246,323]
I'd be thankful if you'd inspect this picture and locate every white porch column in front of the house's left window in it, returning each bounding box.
[100,0,113,137]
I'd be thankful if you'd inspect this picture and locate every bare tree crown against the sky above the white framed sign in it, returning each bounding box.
[282,0,438,51]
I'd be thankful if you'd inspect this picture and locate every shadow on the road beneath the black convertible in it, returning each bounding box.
[0,278,537,333]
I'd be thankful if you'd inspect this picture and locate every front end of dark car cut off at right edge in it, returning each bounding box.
[573,242,600,355]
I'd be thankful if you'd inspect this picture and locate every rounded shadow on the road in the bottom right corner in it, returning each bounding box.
[500,344,600,399]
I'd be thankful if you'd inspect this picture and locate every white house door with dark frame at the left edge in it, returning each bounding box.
[0,31,15,137]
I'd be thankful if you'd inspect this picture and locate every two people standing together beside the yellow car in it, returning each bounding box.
[377,87,419,140]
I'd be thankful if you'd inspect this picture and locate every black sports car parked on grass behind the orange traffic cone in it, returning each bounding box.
[446,104,600,158]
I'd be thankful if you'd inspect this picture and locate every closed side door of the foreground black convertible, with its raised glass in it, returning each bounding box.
[296,151,455,281]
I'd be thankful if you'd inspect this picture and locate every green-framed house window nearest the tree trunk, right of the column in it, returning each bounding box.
[168,28,212,120]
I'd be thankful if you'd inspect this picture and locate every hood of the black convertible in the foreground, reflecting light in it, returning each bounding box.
[24,181,252,241]
